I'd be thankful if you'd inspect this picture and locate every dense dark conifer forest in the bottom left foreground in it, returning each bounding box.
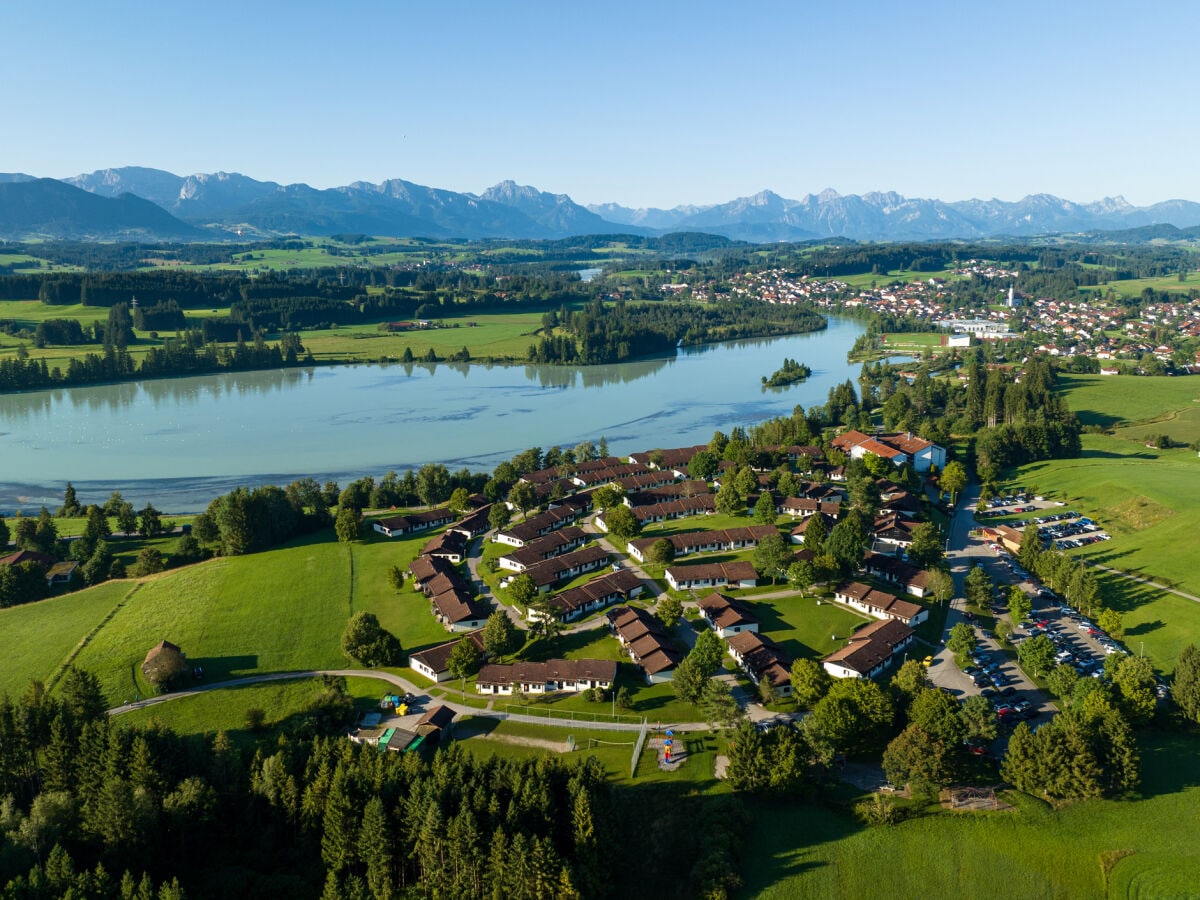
[0,668,746,900]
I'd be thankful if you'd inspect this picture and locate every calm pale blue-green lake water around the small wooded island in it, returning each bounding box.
[0,319,863,515]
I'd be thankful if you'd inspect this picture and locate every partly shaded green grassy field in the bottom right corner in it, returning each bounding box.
[743,733,1200,900]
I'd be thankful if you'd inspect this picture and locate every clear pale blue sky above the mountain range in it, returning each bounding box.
[0,0,1200,206]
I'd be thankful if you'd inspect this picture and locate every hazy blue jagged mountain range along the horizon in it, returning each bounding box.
[0,167,1200,242]
